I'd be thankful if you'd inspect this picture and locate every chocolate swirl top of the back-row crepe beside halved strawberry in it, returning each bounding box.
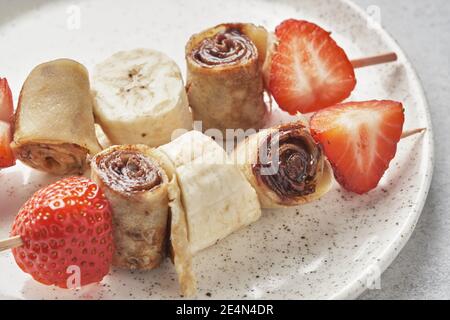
[192,27,258,67]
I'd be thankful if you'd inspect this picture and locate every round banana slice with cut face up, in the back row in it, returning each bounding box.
[92,49,192,147]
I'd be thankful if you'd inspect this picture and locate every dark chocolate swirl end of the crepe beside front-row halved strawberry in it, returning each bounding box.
[253,125,324,199]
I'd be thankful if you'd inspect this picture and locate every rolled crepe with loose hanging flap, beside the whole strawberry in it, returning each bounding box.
[91,145,196,296]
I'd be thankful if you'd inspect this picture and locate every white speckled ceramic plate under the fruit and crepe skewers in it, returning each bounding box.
[0,0,433,299]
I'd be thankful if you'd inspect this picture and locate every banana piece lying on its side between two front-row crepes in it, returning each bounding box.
[158,131,261,254]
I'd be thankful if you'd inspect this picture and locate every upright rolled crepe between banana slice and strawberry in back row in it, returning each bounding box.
[186,24,269,132]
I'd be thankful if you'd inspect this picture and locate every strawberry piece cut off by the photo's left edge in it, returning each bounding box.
[0,78,16,168]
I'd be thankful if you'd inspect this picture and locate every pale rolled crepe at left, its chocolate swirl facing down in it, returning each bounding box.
[12,59,100,175]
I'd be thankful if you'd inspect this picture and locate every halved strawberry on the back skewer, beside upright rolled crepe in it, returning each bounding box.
[269,20,356,114]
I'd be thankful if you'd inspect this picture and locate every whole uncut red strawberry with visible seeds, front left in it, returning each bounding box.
[11,177,114,288]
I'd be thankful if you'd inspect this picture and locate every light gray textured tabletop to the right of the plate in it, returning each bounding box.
[354,0,450,299]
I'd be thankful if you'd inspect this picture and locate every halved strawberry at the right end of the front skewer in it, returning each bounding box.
[311,101,405,194]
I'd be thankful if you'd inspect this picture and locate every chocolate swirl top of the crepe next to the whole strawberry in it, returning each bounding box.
[96,150,162,194]
